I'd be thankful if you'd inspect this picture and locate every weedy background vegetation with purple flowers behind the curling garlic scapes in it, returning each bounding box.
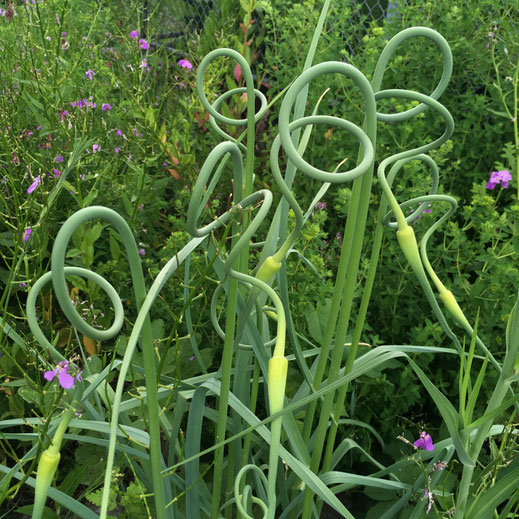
[0,0,519,518]
